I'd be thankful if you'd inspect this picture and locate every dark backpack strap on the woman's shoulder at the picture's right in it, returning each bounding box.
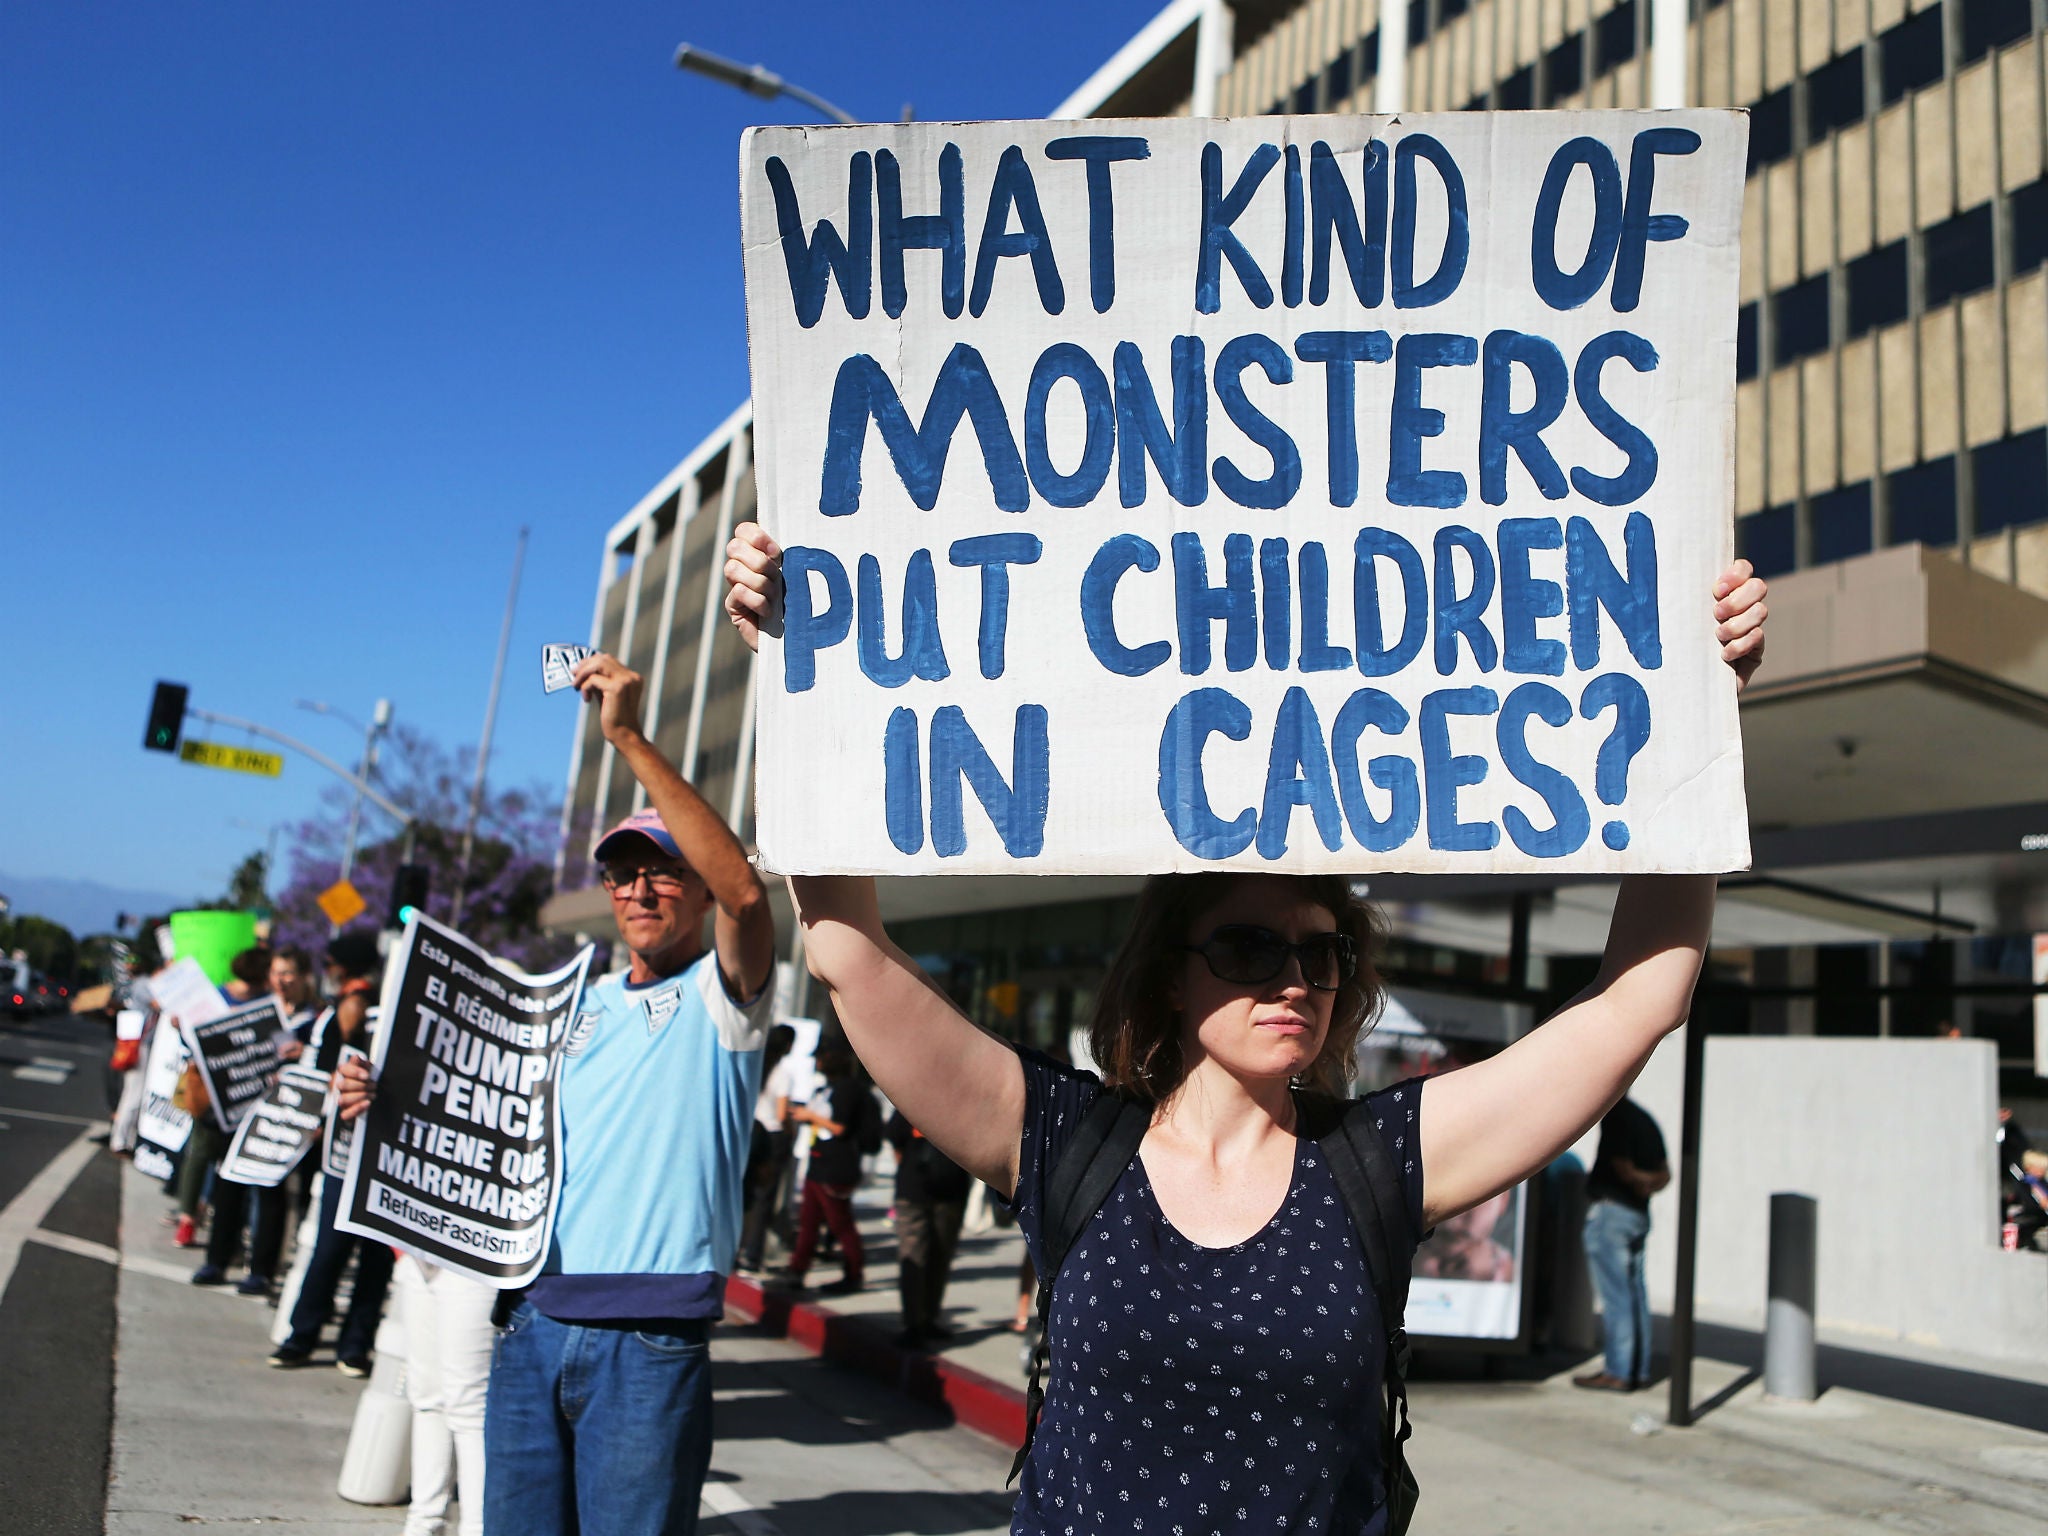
[1303,1100,1417,1532]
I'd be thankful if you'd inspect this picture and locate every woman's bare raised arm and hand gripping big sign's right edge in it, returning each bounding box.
[1421,561,1765,1225]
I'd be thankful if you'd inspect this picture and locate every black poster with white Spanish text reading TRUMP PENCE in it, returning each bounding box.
[336,915,590,1286]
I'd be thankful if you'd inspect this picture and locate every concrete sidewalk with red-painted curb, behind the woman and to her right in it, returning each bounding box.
[729,1182,2048,1536]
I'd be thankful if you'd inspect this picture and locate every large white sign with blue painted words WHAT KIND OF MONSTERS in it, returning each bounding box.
[741,111,1749,874]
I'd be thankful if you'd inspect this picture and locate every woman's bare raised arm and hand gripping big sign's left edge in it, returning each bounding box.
[725,522,1024,1196]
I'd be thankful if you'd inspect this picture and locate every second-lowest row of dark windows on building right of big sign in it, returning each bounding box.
[1735,178,2048,379]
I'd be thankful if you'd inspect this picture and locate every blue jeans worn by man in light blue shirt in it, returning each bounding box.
[483,1303,711,1536]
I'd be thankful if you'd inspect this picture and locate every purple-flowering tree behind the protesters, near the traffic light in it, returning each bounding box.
[272,725,575,971]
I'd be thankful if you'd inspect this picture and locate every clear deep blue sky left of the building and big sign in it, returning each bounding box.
[0,0,1159,921]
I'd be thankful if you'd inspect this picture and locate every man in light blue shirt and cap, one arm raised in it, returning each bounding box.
[344,655,774,1536]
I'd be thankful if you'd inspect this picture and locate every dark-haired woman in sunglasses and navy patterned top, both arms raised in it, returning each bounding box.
[725,524,1763,1532]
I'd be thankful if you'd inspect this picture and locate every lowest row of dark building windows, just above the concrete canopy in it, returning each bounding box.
[1735,428,2048,575]
